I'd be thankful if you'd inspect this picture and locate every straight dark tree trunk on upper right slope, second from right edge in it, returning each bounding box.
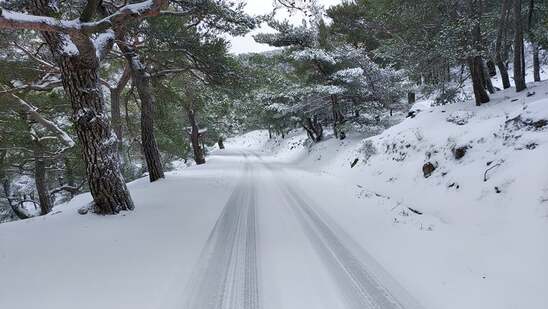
[513,0,527,92]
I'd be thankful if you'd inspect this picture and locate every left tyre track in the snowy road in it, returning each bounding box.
[186,164,260,309]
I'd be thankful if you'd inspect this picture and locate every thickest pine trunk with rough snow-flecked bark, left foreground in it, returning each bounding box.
[32,0,134,214]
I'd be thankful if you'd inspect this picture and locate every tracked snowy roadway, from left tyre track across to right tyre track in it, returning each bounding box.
[185,152,420,309]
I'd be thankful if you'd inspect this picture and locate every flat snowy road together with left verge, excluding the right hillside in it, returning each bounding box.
[0,150,425,309]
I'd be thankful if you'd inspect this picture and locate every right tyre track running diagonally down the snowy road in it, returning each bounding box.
[265,164,421,309]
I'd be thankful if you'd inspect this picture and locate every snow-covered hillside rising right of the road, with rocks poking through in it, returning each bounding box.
[225,82,548,308]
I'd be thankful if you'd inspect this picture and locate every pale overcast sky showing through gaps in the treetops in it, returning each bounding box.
[230,0,342,54]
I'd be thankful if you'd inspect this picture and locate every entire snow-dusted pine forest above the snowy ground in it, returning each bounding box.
[0,0,548,222]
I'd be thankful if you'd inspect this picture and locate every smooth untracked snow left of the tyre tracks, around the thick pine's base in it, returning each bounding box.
[0,159,240,309]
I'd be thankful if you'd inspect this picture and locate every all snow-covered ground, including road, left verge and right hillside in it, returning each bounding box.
[0,83,548,309]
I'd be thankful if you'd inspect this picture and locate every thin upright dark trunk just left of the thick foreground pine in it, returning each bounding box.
[32,139,53,216]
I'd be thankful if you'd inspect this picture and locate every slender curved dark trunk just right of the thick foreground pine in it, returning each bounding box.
[117,35,165,182]
